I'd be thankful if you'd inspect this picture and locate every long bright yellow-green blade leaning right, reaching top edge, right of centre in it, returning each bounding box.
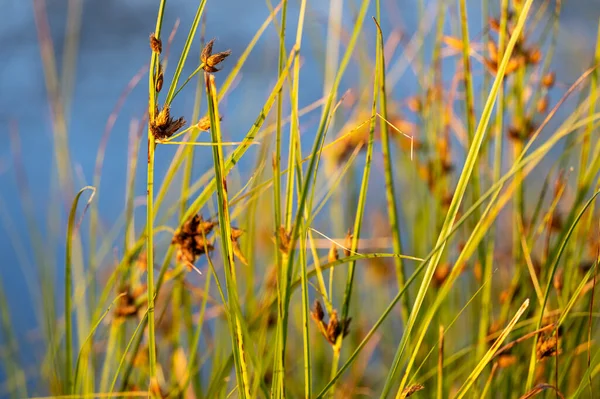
[381,0,533,398]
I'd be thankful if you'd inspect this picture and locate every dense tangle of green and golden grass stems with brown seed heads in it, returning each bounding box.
[0,0,600,398]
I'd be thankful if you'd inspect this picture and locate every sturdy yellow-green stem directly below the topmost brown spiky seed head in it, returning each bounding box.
[205,73,250,398]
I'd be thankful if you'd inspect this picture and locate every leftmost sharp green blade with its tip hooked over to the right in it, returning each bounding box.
[65,186,96,393]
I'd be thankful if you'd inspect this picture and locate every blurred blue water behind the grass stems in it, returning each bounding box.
[0,0,600,397]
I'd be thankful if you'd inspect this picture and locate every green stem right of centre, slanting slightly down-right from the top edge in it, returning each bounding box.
[375,0,410,323]
